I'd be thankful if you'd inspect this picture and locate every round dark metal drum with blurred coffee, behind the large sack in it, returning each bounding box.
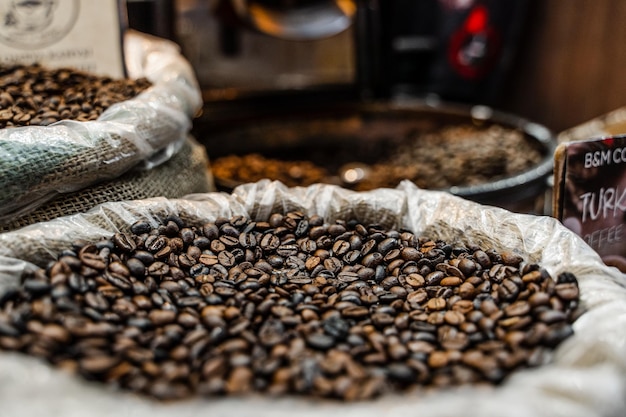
[199,101,556,214]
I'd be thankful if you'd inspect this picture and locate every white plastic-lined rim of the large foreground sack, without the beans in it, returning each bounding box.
[0,181,626,417]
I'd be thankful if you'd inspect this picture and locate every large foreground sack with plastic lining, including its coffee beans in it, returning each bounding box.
[0,180,626,417]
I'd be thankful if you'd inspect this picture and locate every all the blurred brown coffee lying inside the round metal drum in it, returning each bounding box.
[211,124,543,191]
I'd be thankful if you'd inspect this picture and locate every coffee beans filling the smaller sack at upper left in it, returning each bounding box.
[0,64,151,129]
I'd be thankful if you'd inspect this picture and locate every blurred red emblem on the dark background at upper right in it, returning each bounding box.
[448,5,501,79]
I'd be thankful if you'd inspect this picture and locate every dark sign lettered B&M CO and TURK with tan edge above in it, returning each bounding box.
[553,109,626,272]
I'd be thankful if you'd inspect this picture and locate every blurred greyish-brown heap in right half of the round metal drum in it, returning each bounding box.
[355,125,543,190]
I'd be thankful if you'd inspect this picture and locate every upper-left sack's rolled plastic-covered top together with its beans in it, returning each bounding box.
[0,31,202,220]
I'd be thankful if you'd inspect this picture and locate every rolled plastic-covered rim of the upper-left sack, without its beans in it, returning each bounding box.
[0,31,202,221]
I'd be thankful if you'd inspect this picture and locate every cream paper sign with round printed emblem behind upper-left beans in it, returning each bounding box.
[0,0,125,78]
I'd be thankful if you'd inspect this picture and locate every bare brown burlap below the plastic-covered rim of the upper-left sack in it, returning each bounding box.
[0,138,215,232]
